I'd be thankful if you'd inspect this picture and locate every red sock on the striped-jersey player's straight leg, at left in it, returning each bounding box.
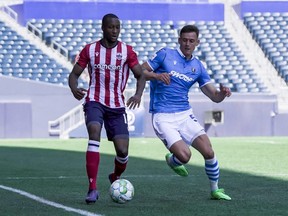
[86,151,100,190]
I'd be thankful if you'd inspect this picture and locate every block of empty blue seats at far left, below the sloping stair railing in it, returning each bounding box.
[0,22,87,86]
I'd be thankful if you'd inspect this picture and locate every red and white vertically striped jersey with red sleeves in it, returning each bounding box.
[77,41,139,108]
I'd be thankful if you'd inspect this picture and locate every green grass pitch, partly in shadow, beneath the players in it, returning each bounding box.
[0,137,288,216]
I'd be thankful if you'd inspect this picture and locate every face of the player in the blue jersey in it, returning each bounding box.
[178,32,199,58]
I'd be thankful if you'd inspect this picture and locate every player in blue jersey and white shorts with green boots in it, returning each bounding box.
[142,25,231,200]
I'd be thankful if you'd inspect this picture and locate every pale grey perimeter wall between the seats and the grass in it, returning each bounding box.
[0,76,288,138]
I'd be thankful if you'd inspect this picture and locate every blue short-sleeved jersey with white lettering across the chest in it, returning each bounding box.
[147,48,211,113]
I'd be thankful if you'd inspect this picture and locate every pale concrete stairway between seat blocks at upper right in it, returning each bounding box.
[225,3,288,113]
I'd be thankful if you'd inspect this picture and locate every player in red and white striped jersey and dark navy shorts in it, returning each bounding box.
[69,14,145,204]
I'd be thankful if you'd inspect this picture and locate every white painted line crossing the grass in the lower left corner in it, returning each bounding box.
[0,185,102,216]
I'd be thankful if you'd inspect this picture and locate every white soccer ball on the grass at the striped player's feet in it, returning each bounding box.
[109,179,134,204]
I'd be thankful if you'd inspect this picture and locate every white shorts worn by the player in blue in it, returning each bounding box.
[152,109,206,149]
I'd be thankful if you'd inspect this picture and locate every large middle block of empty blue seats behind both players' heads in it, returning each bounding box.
[27,19,267,92]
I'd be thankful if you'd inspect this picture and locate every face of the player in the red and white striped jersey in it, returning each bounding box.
[102,18,120,44]
